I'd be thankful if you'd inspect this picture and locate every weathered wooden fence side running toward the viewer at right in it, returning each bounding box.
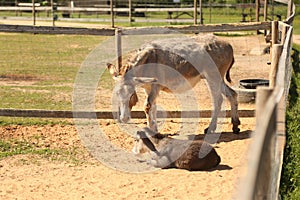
[236,0,295,200]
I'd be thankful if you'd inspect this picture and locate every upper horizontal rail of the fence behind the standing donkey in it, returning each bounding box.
[0,22,271,36]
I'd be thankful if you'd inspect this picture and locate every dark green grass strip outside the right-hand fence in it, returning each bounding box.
[280,45,300,200]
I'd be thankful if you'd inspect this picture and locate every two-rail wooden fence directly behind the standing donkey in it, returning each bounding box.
[0,22,271,119]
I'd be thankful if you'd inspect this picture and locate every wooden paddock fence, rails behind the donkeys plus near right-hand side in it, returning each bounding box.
[0,1,295,200]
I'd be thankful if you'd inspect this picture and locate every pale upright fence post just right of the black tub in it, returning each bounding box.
[269,44,283,88]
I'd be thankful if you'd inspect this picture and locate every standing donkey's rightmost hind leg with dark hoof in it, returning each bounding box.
[222,84,241,134]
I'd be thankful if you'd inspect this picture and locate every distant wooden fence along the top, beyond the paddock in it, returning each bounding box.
[0,0,273,27]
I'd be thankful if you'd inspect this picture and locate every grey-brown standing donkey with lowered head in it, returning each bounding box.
[107,35,240,133]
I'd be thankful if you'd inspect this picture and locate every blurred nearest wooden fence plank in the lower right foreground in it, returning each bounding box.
[236,87,283,200]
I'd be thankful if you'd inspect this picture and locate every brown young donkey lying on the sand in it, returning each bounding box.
[132,128,221,171]
